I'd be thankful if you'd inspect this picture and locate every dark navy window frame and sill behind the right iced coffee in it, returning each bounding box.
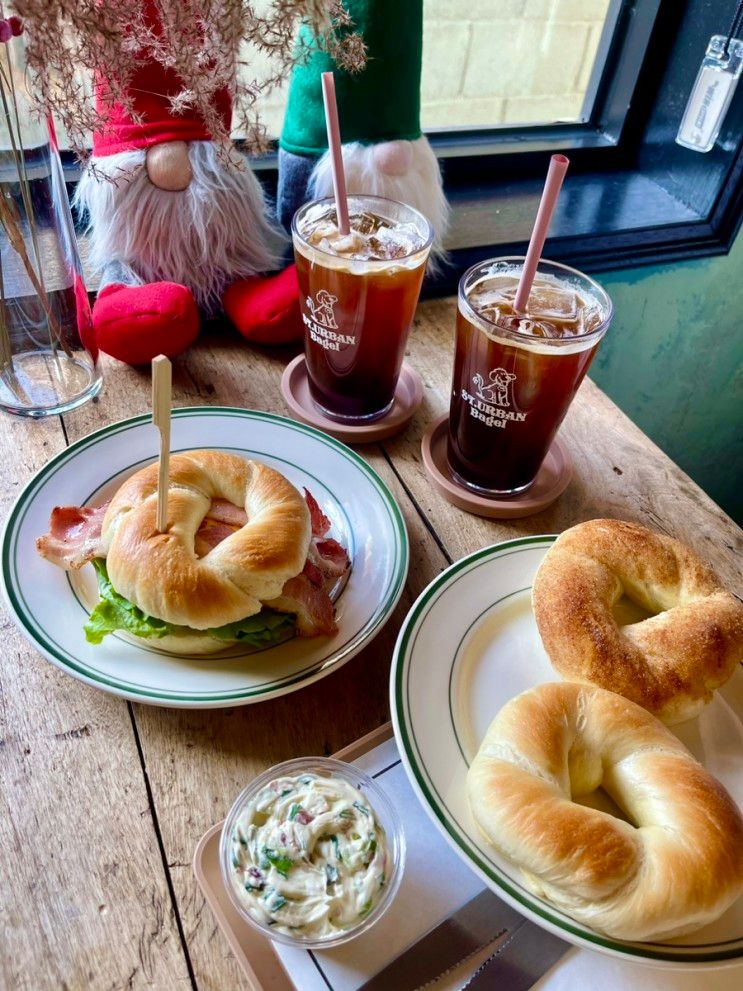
[429,0,743,294]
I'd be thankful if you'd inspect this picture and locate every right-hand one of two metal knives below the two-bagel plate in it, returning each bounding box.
[462,919,570,991]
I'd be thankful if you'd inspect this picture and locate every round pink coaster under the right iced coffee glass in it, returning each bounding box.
[421,413,573,520]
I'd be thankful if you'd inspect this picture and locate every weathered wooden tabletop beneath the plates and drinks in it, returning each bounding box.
[0,300,743,991]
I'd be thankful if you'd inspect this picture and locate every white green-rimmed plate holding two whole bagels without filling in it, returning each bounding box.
[390,536,743,970]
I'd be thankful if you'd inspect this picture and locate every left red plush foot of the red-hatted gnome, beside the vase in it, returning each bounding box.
[93,282,199,365]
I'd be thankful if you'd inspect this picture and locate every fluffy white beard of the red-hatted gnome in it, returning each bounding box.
[75,141,285,313]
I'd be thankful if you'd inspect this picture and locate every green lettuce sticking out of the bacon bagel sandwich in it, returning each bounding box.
[83,558,295,647]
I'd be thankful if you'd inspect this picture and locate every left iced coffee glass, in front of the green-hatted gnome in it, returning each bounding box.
[292,196,433,423]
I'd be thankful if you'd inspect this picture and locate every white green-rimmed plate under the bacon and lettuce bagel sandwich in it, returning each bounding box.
[2,407,408,708]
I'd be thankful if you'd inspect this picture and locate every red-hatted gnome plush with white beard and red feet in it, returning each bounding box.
[76,8,301,364]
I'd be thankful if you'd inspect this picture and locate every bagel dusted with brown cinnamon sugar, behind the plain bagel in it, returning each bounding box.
[532,520,743,723]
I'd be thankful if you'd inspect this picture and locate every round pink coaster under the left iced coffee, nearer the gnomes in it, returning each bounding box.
[281,354,423,444]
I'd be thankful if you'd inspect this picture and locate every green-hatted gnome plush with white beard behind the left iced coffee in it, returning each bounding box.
[277,0,447,255]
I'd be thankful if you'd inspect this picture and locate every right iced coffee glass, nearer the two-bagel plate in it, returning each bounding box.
[448,257,612,497]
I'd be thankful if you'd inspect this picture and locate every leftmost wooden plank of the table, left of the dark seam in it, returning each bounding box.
[0,418,191,991]
